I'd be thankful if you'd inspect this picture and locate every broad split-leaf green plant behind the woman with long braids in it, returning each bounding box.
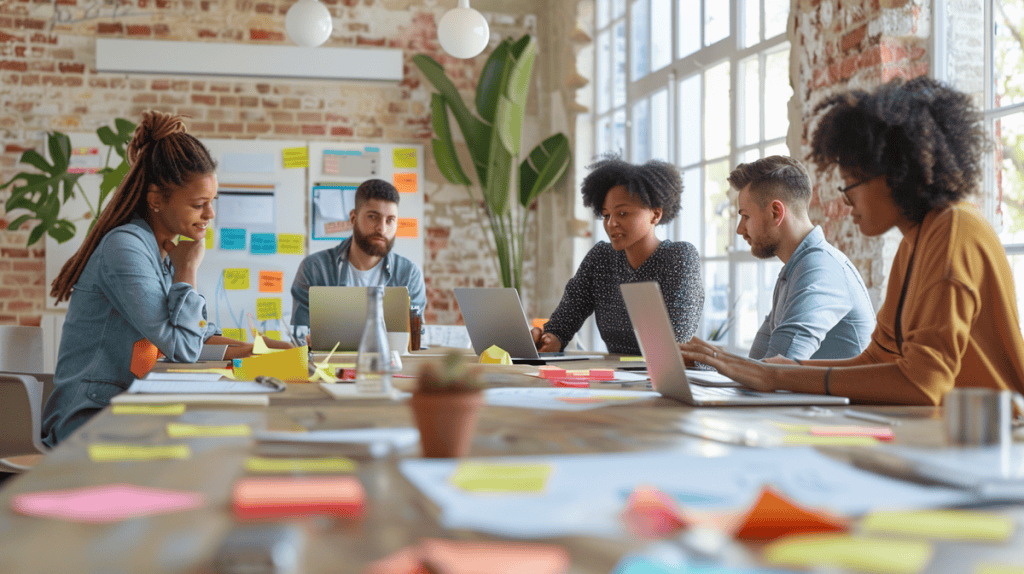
[0,118,135,246]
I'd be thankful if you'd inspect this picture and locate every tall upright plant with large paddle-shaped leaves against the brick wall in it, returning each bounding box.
[413,35,571,290]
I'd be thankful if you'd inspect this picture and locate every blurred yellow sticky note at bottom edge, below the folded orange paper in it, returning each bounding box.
[764,534,932,574]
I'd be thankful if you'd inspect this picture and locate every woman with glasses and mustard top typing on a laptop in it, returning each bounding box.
[681,78,1024,405]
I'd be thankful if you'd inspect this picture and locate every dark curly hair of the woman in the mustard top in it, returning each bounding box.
[810,77,987,223]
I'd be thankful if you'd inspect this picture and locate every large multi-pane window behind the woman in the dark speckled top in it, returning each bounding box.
[591,0,793,352]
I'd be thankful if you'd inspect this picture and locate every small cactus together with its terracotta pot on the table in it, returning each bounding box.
[410,352,483,458]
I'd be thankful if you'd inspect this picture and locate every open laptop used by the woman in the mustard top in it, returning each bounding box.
[622,282,850,406]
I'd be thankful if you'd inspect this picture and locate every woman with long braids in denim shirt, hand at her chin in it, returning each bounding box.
[42,112,282,446]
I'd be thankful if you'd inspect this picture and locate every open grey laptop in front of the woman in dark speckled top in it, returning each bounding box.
[455,288,604,364]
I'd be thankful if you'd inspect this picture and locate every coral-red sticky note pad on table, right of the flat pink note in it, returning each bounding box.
[231,476,367,520]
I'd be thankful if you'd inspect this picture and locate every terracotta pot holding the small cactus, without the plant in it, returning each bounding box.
[409,391,483,458]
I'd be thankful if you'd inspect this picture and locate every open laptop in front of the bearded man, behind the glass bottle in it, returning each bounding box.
[309,286,409,353]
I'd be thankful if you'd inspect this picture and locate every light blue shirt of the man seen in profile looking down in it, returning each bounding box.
[750,227,874,359]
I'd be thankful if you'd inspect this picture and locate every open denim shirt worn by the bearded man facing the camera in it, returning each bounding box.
[292,236,427,331]
